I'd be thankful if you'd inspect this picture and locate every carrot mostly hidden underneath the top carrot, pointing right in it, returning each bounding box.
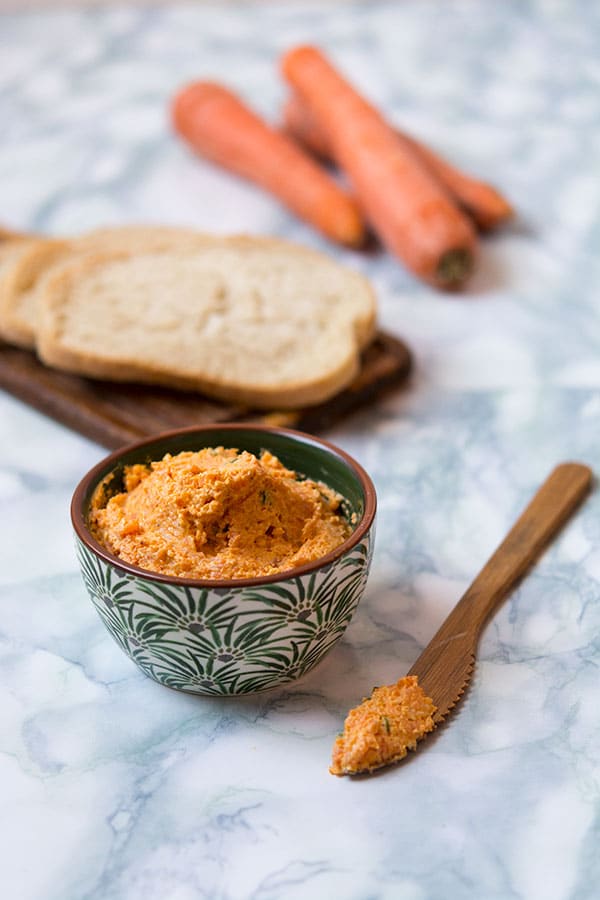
[283,94,514,231]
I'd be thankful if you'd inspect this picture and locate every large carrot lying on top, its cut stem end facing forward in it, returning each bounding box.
[282,46,477,288]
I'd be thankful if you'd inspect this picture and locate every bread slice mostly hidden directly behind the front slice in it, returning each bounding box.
[0,225,211,349]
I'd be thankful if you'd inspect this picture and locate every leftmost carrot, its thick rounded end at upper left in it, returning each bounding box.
[172,81,365,247]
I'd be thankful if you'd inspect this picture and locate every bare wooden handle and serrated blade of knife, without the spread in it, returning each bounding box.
[408,462,593,724]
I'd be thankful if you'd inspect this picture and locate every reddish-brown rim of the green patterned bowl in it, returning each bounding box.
[71,422,377,590]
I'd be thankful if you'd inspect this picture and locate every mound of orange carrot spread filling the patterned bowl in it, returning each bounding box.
[89,447,352,579]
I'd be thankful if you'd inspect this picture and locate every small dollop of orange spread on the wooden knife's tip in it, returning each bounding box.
[329,675,436,775]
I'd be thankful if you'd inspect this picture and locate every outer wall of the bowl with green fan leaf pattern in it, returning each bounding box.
[77,532,373,695]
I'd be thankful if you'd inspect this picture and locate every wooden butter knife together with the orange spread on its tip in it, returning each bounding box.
[329,463,593,775]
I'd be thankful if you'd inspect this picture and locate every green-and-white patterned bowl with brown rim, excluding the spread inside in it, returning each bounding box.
[71,425,376,695]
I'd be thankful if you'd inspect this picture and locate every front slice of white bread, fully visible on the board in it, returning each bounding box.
[37,236,375,408]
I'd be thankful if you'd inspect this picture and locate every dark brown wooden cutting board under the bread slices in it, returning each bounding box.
[0,332,412,449]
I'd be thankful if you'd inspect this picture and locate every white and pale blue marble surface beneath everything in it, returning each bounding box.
[0,0,600,900]
